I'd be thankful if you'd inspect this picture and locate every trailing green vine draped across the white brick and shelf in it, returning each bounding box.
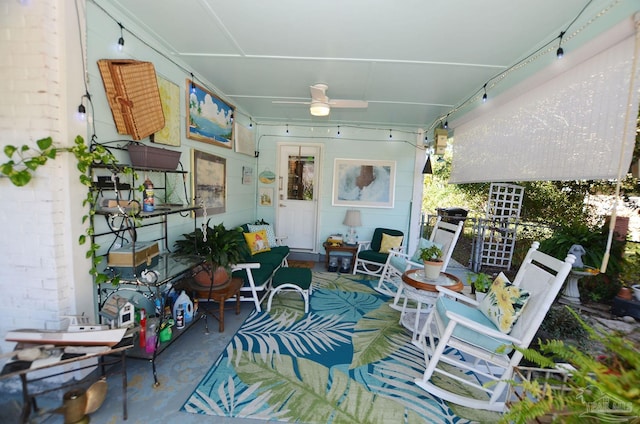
[0,135,134,284]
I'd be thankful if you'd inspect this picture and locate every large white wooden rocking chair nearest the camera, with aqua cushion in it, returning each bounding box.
[415,242,575,411]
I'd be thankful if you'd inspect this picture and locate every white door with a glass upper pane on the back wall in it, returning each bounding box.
[276,144,321,252]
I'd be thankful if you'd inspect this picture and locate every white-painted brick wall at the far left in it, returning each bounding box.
[0,0,92,362]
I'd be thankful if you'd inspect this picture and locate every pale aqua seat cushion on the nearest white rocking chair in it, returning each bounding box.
[436,297,511,354]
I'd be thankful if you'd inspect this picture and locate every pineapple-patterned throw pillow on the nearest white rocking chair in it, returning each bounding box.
[478,273,529,334]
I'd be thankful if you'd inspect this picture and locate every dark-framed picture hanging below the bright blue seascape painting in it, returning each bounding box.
[191,149,227,216]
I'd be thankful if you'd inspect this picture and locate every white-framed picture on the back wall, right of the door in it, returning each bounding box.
[332,159,396,208]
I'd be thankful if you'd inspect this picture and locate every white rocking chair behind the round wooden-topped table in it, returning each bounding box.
[376,216,464,296]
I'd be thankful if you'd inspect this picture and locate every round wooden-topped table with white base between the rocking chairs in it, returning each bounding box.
[396,269,464,343]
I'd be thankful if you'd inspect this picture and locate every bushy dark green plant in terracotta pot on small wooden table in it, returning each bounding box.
[174,221,249,291]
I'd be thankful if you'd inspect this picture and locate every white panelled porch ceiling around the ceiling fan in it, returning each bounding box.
[109,0,624,128]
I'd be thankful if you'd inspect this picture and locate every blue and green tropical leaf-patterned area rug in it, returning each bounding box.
[182,272,500,424]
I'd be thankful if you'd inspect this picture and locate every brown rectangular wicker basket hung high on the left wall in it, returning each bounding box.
[98,59,165,140]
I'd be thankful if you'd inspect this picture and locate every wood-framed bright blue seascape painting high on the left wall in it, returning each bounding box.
[187,79,233,149]
